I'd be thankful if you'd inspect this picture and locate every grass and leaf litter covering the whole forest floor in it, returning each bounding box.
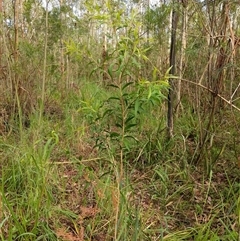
[0,82,240,241]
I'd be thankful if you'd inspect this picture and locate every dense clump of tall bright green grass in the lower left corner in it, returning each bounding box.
[0,132,58,240]
